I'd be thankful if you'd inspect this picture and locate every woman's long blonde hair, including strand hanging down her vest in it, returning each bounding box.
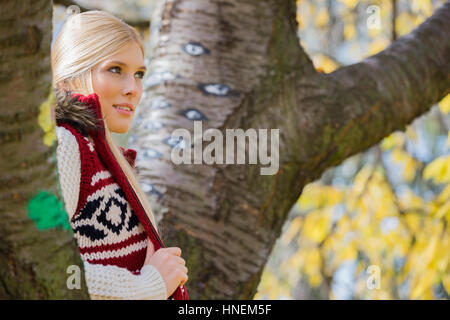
[51,10,157,230]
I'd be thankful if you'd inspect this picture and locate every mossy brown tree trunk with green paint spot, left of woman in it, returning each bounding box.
[0,0,88,299]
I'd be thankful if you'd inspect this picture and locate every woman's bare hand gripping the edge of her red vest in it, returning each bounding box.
[144,240,188,297]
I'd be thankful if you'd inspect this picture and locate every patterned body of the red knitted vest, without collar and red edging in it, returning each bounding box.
[61,124,149,274]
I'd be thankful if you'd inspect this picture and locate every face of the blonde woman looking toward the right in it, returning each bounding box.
[91,42,146,133]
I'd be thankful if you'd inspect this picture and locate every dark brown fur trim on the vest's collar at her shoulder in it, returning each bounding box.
[53,89,100,135]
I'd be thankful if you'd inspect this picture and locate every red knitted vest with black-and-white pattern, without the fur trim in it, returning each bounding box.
[57,93,188,300]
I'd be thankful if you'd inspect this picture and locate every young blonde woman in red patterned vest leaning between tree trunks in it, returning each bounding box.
[51,11,188,299]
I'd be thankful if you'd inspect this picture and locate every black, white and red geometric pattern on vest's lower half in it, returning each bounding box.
[71,171,147,273]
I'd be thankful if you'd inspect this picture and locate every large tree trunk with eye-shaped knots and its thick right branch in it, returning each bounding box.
[130,0,450,299]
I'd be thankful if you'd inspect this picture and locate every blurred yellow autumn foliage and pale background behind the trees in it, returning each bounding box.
[53,0,450,299]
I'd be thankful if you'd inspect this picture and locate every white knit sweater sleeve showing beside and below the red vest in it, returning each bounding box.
[56,127,167,299]
